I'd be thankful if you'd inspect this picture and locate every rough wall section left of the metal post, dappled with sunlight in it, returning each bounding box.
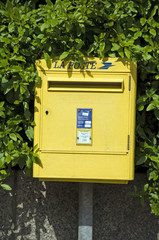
[0,171,78,240]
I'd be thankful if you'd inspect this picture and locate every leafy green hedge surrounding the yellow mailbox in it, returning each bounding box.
[0,0,159,215]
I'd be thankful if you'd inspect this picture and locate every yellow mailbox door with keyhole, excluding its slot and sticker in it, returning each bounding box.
[40,75,130,153]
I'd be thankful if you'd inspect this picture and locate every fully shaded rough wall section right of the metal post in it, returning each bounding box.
[93,174,159,240]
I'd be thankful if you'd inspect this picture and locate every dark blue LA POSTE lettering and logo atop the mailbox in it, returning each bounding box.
[53,61,115,70]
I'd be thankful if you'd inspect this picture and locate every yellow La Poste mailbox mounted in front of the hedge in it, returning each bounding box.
[33,58,136,183]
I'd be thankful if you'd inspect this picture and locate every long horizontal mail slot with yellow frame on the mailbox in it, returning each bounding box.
[48,80,123,92]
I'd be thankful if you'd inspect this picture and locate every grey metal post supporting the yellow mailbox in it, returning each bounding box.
[78,183,93,240]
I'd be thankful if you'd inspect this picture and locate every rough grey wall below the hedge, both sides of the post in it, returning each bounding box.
[0,171,159,240]
